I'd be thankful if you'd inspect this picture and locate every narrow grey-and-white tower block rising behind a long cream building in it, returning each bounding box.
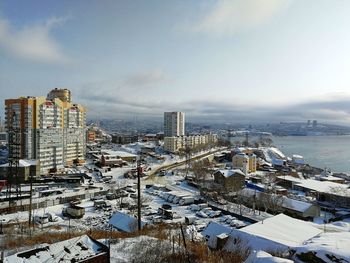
[164,111,185,137]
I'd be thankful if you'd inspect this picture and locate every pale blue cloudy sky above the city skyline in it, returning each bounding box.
[0,0,350,125]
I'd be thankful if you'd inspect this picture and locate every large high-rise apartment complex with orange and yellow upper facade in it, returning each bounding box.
[5,89,86,174]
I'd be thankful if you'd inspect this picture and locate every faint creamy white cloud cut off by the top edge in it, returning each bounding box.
[190,0,290,34]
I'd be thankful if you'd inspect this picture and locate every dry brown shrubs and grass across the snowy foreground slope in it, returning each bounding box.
[0,224,249,263]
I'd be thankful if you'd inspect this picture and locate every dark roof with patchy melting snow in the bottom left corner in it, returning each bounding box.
[4,235,108,263]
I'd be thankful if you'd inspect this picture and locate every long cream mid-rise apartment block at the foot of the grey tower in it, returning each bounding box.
[164,133,218,153]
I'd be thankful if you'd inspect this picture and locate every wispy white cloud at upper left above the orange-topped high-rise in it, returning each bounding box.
[0,17,70,63]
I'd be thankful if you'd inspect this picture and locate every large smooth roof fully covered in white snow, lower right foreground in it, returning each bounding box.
[240,214,322,247]
